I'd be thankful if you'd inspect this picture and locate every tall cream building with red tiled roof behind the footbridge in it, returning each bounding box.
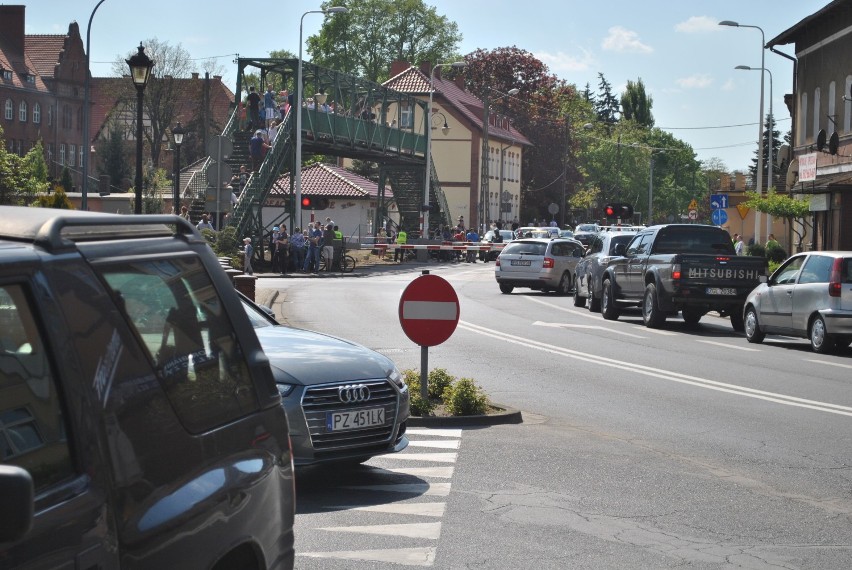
[383,57,531,227]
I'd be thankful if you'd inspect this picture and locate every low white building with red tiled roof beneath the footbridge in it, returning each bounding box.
[263,163,399,237]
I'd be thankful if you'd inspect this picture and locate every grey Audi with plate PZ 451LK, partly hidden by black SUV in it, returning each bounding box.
[240,295,409,467]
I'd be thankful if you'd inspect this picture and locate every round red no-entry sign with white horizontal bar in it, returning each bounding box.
[399,275,459,346]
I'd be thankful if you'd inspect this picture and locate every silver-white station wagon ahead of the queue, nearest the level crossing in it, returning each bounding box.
[494,238,583,295]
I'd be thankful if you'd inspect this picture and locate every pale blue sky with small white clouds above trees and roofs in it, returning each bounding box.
[24,0,828,170]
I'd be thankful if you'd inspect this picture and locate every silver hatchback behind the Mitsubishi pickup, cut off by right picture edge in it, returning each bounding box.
[743,251,852,353]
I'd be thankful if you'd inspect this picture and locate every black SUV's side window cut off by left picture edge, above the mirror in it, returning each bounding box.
[0,285,75,493]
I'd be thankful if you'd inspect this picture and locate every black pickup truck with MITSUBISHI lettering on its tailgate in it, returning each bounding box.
[601,224,767,331]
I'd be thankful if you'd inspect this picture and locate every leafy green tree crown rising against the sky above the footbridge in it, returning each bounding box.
[307,0,462,82]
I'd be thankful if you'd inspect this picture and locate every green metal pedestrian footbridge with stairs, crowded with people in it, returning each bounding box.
[186,58,451,242]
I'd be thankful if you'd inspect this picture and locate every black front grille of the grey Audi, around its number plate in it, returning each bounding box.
[302,380,399,451]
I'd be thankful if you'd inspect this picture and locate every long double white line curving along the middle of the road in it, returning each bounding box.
[458,321,852,417]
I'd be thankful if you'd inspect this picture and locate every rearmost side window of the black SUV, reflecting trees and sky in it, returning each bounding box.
[100,257,258,433]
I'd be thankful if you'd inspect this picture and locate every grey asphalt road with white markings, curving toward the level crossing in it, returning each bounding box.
[258,264,852,569]
